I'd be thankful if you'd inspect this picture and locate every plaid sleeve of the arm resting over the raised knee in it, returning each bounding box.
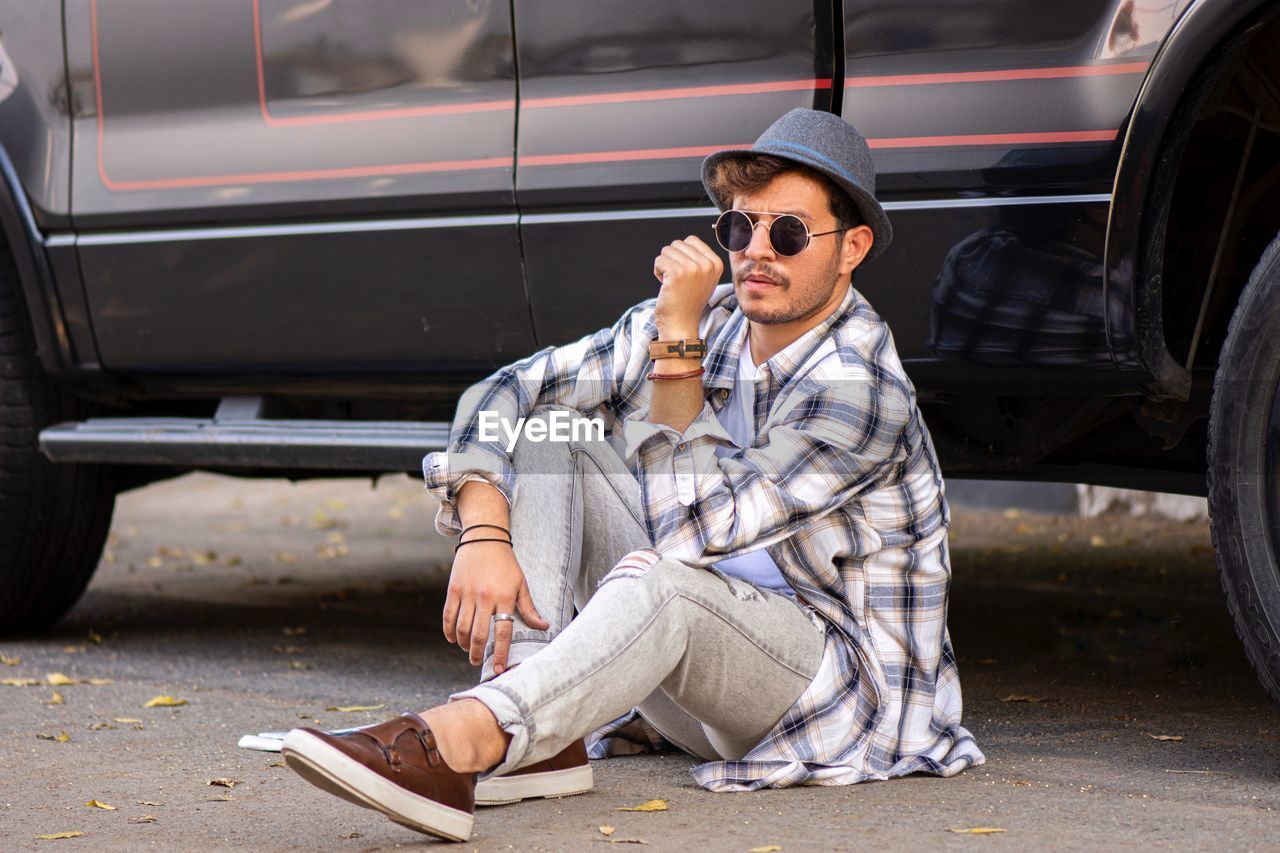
[422,297,657,535]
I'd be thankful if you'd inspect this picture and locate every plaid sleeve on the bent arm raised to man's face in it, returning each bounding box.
[625,374,910,566]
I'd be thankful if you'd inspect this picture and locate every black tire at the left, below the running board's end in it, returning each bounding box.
[0,245,115,635]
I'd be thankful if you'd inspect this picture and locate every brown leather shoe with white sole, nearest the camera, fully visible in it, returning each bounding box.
[280,713,476,841]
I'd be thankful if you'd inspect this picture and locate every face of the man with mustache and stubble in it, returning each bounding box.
[730,172,872,324]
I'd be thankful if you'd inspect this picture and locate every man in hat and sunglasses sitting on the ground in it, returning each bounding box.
[283,109,983,840]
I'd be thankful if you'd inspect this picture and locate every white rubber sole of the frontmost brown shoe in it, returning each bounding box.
[280,731,475,841]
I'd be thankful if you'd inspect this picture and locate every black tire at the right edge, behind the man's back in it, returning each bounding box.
[1208,227,1280,703]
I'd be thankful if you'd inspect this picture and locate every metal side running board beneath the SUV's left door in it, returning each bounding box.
[40,397,449,474]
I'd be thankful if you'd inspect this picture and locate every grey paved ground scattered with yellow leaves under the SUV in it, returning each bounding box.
[0,475,1280,852]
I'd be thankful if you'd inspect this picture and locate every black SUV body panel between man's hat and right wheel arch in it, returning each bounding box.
[841,0,1188,371]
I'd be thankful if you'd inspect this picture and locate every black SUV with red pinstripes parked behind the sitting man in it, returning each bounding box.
[0,0,1280,699]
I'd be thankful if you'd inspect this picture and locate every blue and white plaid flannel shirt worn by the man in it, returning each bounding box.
[422,283,984,790]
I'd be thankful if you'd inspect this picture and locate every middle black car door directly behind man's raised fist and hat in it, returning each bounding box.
[513,0,835,345]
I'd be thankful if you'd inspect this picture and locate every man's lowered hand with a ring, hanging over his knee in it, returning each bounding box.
[444,530,550,672]
